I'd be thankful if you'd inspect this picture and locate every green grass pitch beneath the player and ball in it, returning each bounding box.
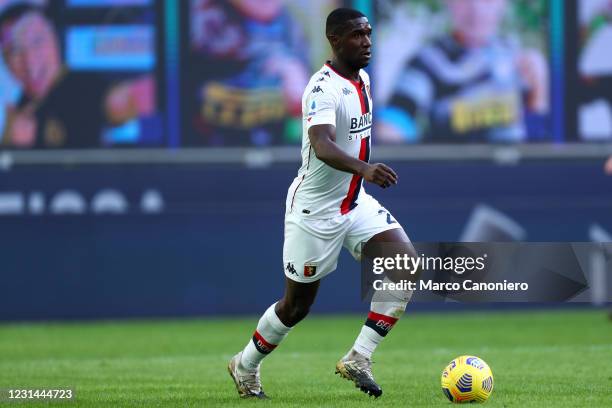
[0,311,612,408]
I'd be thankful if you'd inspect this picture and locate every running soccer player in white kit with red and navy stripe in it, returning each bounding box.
[228,8,414,398]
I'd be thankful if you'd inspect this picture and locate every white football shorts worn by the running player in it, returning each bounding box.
[283,192,401,283]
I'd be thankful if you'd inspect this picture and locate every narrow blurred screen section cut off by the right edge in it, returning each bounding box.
[572,0,612,141]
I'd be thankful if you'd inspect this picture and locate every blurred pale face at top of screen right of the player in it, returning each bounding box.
[447,0,506,46]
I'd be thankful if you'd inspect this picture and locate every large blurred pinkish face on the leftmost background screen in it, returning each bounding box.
[2,13,61,97]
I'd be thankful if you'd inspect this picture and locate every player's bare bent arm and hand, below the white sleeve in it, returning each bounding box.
[308,124,397,188]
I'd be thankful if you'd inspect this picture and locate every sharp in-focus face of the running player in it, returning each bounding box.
[332,17,372,69]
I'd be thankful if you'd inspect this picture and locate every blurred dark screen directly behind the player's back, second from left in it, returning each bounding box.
[182,0,341,146]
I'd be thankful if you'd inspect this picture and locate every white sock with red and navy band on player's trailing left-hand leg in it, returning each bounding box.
[240,303,291,370]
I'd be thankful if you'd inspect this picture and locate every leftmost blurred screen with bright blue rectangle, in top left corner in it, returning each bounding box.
[0,0,164,149]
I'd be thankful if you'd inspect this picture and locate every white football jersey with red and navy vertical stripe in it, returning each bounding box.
[287,62,372,219]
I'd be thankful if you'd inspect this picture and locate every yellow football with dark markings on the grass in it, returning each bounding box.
[442,356,493,403]
